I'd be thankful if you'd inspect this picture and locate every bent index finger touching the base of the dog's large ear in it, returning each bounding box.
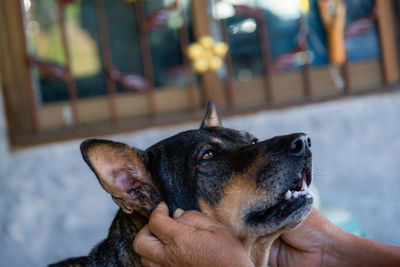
[148,202,183,244]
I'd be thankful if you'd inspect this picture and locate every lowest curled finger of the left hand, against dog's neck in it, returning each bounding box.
[133,225,165,263]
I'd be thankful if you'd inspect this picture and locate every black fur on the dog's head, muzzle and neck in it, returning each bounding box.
[50,101,311,266]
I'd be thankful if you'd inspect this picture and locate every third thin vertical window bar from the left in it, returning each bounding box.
[134,1,157,118]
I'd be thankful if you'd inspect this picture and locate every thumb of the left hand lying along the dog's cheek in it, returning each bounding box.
[174,210,223,230]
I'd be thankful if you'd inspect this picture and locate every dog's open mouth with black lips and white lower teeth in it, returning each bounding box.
[247,169,312,224]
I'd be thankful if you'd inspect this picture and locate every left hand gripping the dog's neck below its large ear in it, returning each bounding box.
[133,202,253,267]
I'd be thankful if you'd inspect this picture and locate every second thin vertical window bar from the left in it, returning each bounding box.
[94,0,119,123]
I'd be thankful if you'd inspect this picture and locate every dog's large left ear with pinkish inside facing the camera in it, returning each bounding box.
[81,139,160,216]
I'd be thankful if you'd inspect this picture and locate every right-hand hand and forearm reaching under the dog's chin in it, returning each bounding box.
[269,209,400,267]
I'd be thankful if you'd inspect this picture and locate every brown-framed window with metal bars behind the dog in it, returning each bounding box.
[0,0,399,148]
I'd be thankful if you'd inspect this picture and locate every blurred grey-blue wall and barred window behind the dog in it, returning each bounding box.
[0,0,400,266]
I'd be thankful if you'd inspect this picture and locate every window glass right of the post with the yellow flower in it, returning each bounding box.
[212,0,379,79]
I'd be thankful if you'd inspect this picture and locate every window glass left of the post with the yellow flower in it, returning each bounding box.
[24,0,195,103]
